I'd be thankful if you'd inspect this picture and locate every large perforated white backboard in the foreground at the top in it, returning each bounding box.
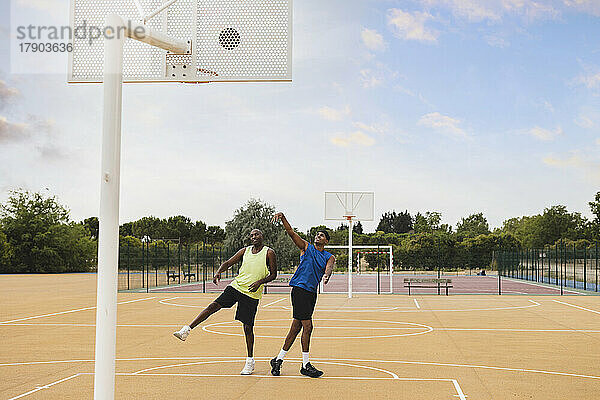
[69,0,292,83]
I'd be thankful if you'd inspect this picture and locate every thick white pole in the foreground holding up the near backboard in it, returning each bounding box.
[94,14,125,400]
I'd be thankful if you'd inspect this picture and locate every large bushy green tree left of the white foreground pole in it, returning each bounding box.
[0,191,96,273]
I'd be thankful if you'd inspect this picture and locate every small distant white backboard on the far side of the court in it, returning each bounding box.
[325,192,375,221]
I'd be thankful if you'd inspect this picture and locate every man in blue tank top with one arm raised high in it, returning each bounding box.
[271,213,335,378]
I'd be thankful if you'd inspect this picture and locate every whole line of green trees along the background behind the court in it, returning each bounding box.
[0,191,600,273]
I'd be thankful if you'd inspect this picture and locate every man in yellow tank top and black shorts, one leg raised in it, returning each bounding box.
[173,229,277,375]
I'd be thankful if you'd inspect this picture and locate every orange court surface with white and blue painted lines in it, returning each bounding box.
[0,274,600,400]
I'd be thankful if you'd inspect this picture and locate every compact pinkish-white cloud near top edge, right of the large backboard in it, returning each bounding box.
[387,8,439,42]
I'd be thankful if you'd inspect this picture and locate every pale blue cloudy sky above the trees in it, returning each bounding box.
[0,0,600,232]
